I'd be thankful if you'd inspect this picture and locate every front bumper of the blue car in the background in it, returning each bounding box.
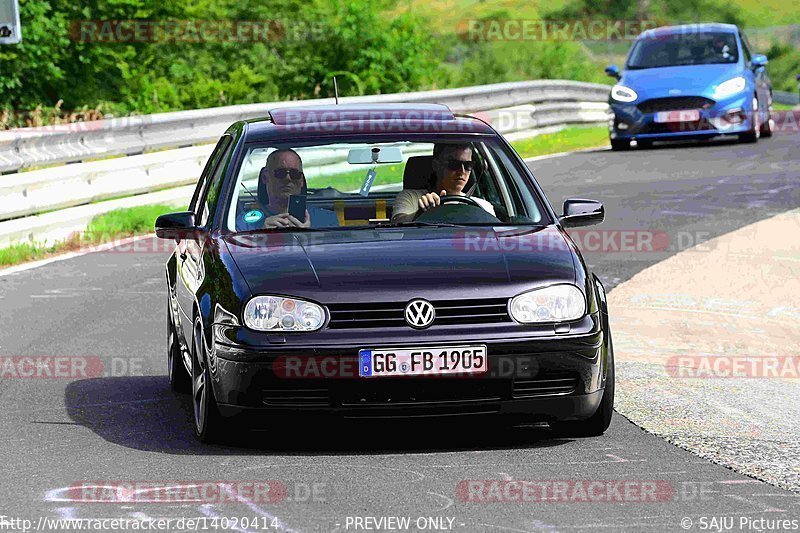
[609,92,754,141]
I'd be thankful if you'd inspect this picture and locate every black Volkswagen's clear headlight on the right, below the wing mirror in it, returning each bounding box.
[508,284,586,324]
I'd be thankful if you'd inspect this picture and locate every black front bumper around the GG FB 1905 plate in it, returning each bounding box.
[211,315,608,421]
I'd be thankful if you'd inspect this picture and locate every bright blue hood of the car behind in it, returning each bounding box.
[619,64,743,101]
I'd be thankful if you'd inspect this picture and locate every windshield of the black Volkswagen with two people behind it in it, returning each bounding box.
[225,136,549,232]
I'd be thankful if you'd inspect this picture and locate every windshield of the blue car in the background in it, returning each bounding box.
[627,32,739,69]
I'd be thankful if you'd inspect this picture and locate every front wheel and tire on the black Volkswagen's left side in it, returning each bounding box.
[192,318,228,444]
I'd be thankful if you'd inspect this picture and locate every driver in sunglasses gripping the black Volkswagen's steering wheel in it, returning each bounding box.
[392,143,496,222]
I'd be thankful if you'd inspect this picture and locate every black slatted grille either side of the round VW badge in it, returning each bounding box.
[328,298,511,329]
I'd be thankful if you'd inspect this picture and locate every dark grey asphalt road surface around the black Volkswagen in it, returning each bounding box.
[0,130,800,532]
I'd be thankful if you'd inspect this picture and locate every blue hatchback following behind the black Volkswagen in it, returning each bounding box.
[606,24,773,150]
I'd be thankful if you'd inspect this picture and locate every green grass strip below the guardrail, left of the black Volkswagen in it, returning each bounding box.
[0,204,179,267]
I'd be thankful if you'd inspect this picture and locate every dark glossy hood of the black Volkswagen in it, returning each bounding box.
[223,226,576,302]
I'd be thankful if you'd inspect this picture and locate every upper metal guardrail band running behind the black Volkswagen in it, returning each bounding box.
[0,80,609,173]
